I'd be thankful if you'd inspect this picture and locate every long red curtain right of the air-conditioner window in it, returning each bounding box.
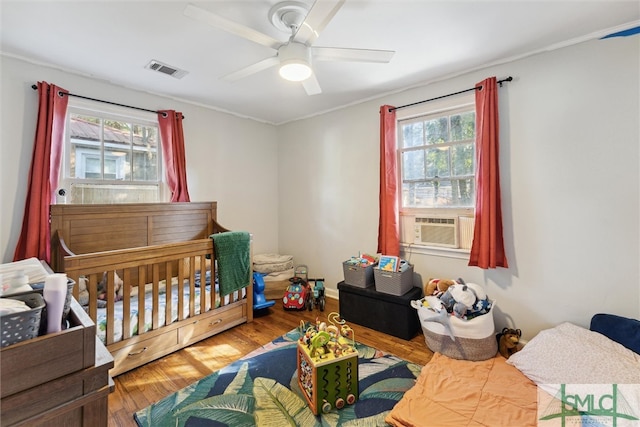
[469,77,509,269]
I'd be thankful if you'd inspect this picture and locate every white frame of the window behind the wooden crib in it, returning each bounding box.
[56,97,170,203]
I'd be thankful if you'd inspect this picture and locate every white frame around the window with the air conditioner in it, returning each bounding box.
[396,92,477,259]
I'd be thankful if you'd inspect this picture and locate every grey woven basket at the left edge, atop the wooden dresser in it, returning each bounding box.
[0,292,45,348]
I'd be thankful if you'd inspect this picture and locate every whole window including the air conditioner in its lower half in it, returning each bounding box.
[398,97,475,252]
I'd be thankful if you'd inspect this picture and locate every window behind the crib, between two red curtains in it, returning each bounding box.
[60,101,165,204]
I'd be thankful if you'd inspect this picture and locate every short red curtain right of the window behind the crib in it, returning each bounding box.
[158,110,190,202]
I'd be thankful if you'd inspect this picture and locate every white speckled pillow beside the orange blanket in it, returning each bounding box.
[507,323,640,386]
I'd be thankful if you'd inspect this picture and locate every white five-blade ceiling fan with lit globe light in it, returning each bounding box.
[184,0,395,95]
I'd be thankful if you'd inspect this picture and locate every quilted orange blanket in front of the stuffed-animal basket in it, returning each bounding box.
[385,353,538,427]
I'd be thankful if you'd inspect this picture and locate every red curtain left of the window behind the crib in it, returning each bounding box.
[13,82,69,262]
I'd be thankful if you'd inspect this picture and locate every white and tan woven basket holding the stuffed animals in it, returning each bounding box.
[411,301,498,361]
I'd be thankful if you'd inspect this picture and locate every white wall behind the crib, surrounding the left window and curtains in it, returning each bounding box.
[0,57,278,262]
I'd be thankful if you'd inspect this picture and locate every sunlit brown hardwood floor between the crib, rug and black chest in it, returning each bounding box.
[109,298,433,426]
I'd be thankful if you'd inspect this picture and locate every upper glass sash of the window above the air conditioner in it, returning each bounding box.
[399,106,475,208]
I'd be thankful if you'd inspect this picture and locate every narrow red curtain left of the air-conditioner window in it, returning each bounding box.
[378,105,400,256]
